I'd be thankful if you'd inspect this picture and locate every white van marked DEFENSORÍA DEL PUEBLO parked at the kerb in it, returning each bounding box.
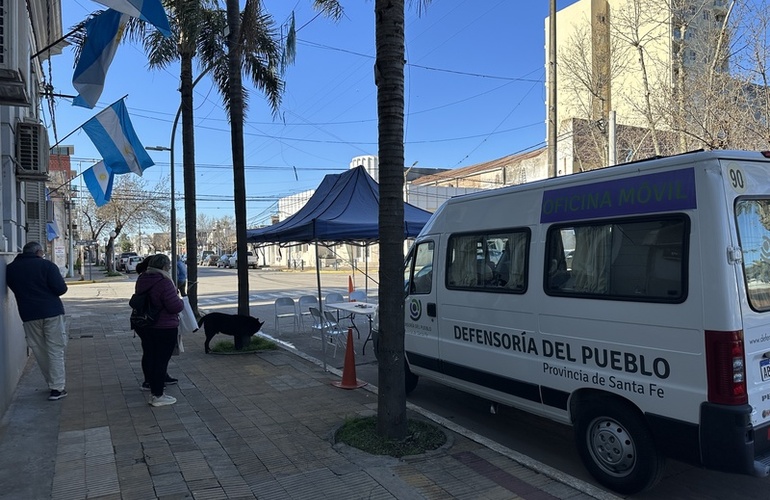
[405,151,770,493]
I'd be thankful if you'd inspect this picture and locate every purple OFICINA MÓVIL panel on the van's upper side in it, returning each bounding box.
[540,168,697,223]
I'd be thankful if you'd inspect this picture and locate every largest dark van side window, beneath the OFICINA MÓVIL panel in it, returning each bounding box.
[545,216,689,302]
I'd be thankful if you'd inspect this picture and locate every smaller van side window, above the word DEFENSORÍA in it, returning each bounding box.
[447,229,529,293]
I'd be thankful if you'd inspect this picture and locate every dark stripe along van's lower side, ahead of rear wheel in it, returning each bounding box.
[406,351,569,410]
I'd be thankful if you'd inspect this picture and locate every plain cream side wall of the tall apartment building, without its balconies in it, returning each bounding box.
[545,0,672,133]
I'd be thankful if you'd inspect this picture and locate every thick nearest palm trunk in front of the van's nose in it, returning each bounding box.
[374,0,407,439]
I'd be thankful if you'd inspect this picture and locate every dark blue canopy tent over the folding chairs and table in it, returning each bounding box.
[246,166,431,368]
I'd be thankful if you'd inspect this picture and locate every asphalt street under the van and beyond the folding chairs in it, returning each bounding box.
[144,268,770,500]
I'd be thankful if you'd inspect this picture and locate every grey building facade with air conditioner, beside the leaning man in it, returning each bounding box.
[0,0,62,415]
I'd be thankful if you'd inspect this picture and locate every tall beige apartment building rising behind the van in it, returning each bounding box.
[545,0,729,173]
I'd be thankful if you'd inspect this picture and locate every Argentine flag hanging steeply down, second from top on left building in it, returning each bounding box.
[72,9,128,109]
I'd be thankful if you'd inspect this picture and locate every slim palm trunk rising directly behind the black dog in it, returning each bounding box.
[227,0,249,316]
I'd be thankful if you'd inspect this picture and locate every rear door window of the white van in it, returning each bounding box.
[735,199,770,311]
